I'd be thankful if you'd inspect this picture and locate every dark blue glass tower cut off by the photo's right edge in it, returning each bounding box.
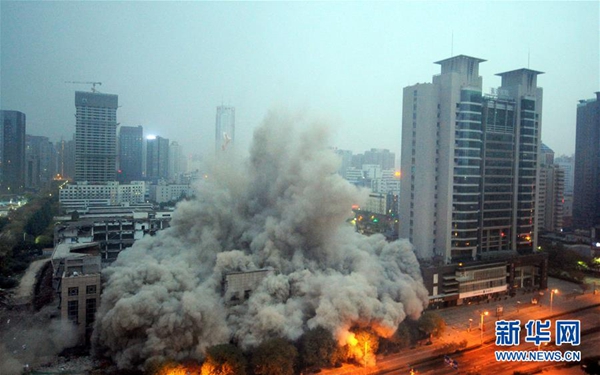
[573,91,600,229]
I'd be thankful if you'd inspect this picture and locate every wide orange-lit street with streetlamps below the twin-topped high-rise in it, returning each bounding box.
[323,278,600,375]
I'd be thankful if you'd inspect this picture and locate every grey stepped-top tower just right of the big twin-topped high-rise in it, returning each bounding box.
[537,143,565,232]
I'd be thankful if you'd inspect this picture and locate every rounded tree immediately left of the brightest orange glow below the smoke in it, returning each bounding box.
[300,326,338,368]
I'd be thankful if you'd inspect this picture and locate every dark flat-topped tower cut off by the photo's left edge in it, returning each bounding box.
[0,110,26,193]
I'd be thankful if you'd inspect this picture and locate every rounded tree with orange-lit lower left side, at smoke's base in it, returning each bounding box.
[202,344,246,375]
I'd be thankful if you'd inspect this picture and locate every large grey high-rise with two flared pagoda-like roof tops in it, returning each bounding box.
[400,55,542,262]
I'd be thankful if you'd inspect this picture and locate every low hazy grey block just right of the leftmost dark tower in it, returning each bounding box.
[25,134,56,188]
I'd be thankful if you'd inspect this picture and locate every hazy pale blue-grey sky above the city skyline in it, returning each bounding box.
[0,1,600,159]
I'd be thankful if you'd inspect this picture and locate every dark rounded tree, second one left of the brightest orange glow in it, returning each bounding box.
[252,338,298,375]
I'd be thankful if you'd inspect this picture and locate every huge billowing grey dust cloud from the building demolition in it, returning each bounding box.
[95,112,427,368]
